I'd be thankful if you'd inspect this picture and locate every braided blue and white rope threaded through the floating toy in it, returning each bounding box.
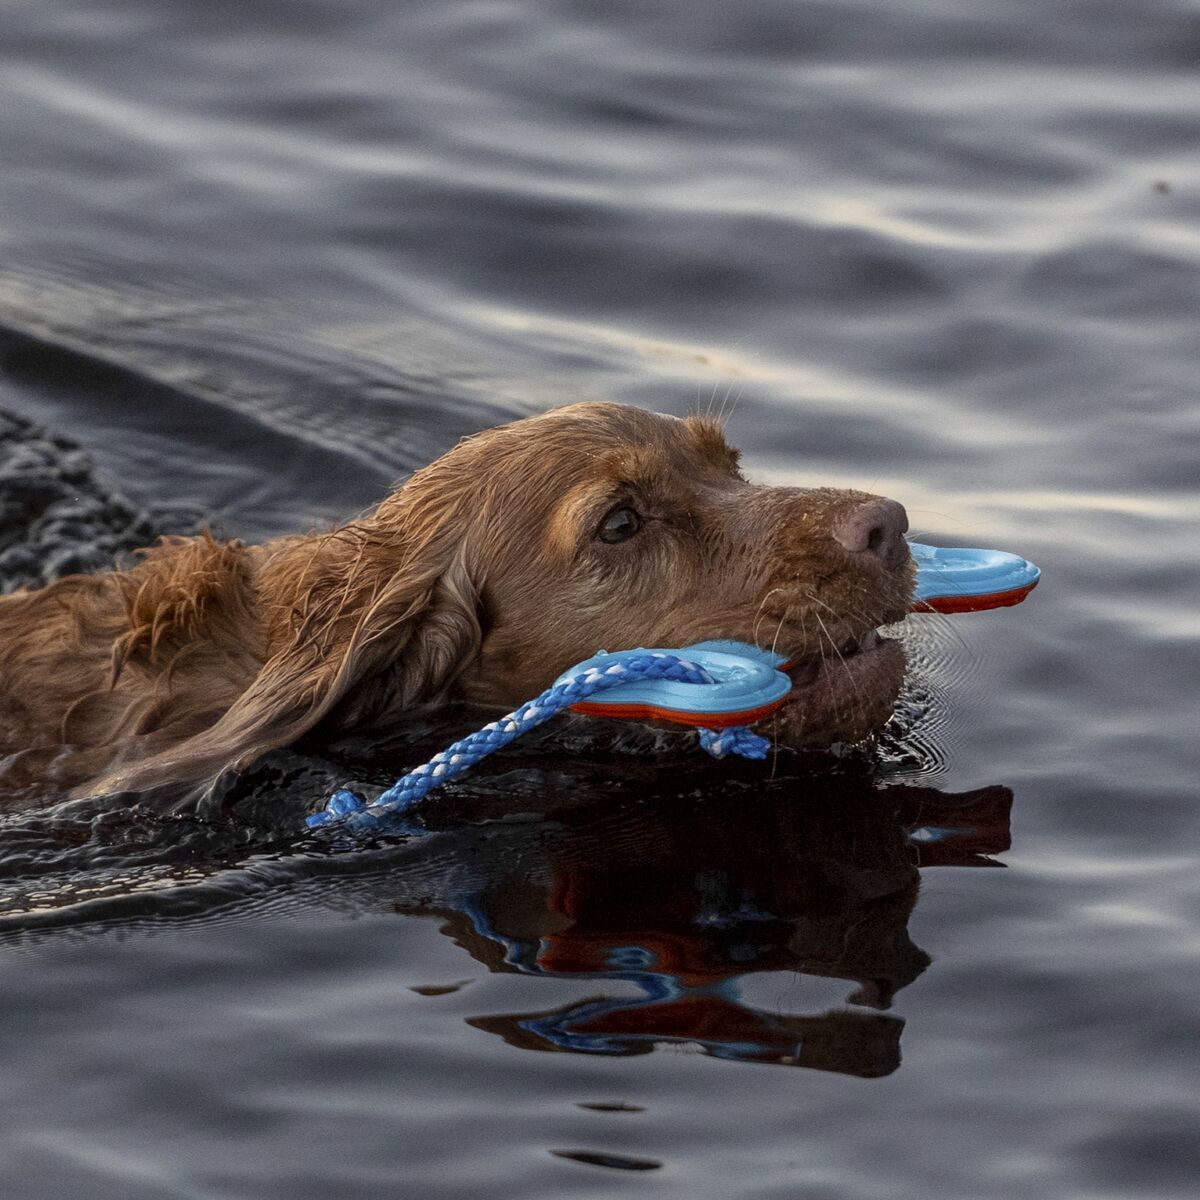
[307,650,770,830]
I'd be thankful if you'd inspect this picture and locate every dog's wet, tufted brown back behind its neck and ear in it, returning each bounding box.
[0,535,265,790]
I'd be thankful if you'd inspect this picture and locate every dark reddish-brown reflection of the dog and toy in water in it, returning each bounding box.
[386,779,1012,1076]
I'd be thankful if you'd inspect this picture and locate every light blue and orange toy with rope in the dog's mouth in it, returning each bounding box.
[307,542,1040,832]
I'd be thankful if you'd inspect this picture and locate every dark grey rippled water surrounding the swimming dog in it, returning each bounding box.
[0,0,1200,1200]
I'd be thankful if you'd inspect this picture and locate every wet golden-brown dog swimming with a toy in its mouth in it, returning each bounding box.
[0,404,913,794]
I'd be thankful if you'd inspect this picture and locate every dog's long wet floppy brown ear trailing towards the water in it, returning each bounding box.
[79,526,481,796]
